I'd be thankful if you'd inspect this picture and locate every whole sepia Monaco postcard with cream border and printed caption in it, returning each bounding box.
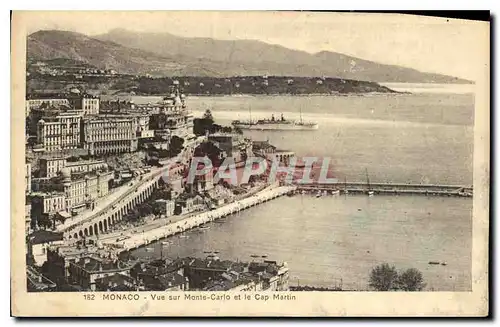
[11,11,490,316]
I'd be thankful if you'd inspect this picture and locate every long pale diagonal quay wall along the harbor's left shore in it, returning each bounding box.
[102,186,296,252]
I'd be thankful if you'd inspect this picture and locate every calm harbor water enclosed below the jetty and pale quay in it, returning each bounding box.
[130,194,472,291]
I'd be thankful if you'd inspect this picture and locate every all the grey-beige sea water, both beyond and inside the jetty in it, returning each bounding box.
[124,83,474,291]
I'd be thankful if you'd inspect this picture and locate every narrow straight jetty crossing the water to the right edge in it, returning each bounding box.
[296,182,473,197]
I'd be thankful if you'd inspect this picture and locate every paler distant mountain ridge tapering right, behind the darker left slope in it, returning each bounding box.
[95,29,469,83]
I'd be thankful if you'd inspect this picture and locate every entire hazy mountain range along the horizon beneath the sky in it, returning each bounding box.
[27,29,470,83]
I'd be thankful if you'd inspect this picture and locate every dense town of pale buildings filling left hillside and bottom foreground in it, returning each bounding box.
[25,84,288,291]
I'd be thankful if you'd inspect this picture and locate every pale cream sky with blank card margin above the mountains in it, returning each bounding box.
[21,11,489,80]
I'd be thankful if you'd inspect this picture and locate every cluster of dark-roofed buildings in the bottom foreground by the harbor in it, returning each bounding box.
[36,243,289,291]
